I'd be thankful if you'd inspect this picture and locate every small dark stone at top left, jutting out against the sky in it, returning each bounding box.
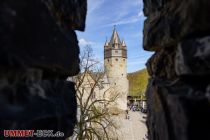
[42,0,87,31]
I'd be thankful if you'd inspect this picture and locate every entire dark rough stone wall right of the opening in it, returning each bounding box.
[143,0,210,140]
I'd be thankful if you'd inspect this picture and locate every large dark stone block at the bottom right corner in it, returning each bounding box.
[147,79,210,140]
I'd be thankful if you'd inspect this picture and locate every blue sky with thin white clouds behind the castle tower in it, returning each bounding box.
[77,0,152,72]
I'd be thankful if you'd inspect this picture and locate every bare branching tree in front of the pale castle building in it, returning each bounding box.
[69,46,119,140]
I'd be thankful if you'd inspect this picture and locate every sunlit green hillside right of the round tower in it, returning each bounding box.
[128,69,149,96]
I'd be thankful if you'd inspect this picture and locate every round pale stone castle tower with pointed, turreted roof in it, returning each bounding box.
[104,28,129,110]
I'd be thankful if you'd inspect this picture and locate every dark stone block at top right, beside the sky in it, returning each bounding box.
[143,0,210,51]
